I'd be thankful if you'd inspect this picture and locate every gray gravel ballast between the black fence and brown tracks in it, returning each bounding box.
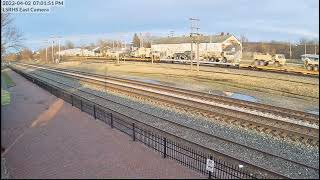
[13,65,319,178]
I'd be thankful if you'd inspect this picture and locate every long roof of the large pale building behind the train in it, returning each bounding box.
[152,35,232,44]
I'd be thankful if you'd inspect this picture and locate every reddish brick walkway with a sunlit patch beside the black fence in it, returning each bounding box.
[1,71,201,179]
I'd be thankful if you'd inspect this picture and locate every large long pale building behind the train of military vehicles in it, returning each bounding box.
[151,33,242,58]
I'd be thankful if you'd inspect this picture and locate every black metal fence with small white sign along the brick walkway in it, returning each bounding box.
[12,68,261,179]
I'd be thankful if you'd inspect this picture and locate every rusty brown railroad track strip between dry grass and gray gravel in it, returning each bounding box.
[18,65,319,146]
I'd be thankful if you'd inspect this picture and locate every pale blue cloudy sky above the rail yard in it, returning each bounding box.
[10,0,319,50]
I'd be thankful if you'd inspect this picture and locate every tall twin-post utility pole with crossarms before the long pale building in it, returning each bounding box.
[189,18,200,72]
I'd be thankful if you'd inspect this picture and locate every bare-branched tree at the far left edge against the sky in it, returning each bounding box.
[1,13,23,57]
